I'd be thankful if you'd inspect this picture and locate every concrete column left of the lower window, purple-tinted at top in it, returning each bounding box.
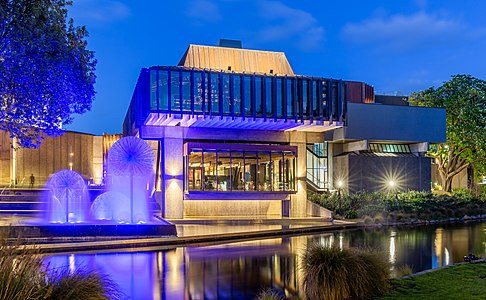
[160,135,184,219]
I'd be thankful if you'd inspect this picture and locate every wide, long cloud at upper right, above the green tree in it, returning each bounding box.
[341,11,484,52]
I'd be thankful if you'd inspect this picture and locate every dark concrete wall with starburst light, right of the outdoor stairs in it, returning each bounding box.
[334,155,431,193]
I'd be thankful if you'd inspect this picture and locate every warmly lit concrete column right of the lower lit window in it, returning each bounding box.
[290,131,307,218]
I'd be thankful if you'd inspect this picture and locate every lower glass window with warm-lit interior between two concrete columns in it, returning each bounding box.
[184,143,297,192]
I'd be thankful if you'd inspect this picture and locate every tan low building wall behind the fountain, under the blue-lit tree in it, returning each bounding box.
[0,131,121,188]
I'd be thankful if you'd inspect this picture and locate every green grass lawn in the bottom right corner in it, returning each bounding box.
[378,262,486,300]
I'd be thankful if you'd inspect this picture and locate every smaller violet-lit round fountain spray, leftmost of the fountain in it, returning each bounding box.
[46,170,89,223]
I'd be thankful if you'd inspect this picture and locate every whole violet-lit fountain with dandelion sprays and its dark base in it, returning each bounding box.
[13,136,177,237]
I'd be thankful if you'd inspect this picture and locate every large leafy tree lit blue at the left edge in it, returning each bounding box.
[0,0,96,148]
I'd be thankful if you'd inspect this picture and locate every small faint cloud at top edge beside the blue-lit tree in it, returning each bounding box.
[71,0,131,23]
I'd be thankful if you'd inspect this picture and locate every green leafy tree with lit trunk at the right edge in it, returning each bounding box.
[410,75,486,192]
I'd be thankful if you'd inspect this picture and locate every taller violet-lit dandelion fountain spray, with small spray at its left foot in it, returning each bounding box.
[91,136,154,224]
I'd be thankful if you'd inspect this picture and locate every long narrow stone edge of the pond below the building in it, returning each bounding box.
[11,222,361,254]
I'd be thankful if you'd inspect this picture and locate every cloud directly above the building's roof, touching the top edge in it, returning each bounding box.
[256,1,325,51]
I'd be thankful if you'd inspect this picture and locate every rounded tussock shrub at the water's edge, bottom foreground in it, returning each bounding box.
[301,244,390,300]
